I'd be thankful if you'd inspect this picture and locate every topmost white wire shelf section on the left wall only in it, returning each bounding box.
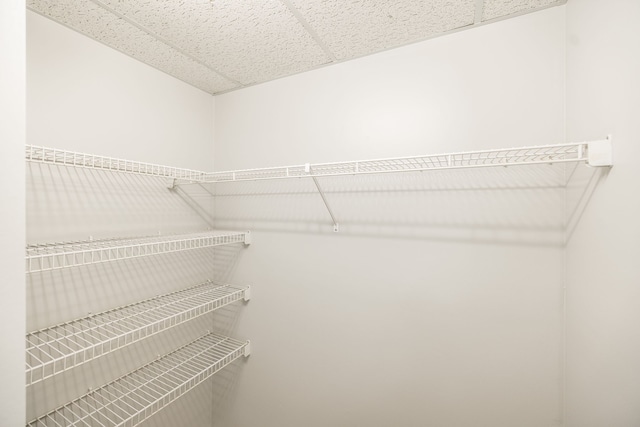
[25,145,205,182]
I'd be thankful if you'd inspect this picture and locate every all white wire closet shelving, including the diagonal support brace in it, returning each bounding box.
[25,138,612,427]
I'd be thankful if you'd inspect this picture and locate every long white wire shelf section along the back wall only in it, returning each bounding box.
[201,139,611,183]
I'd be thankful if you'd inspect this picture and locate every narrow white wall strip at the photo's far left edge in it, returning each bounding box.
[0,0,25,426]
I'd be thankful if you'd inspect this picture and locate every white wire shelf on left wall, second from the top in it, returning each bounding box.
[26,231,251,273]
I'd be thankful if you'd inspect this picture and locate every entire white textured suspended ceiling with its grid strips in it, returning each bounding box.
[27,0,566,95]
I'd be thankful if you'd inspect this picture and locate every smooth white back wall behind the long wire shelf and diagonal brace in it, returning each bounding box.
[214,8,565,427]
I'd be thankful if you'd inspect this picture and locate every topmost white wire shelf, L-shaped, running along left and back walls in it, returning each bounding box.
[25,137,612,185]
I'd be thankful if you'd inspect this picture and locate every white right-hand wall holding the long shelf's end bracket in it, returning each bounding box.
[566,0,640,427]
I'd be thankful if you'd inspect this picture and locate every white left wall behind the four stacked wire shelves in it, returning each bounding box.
[26,13,228,427]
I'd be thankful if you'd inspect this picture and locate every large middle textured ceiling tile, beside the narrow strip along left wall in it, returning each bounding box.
[95,0,330,85]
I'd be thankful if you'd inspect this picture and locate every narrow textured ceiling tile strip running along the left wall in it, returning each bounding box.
[27,0,238,94]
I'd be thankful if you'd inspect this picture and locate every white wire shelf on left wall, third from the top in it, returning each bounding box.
[26,282,250,385]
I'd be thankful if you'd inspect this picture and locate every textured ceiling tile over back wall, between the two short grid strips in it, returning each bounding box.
[290,0,476,60]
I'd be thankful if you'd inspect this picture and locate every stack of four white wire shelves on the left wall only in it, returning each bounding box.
[25,145,251,427]
